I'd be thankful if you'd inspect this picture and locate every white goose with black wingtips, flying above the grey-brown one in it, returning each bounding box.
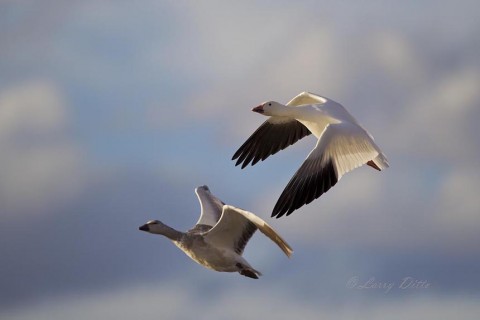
[232,92,388,218]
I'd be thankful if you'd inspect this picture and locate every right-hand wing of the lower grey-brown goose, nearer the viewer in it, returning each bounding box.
[204,205,293,257]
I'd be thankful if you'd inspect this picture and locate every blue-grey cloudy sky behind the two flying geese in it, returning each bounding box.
[0,0,480,320]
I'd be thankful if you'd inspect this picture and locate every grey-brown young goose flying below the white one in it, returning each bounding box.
[139,186,293,279]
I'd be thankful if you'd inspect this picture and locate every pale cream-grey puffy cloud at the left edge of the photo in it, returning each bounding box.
[0,80,82,214]
